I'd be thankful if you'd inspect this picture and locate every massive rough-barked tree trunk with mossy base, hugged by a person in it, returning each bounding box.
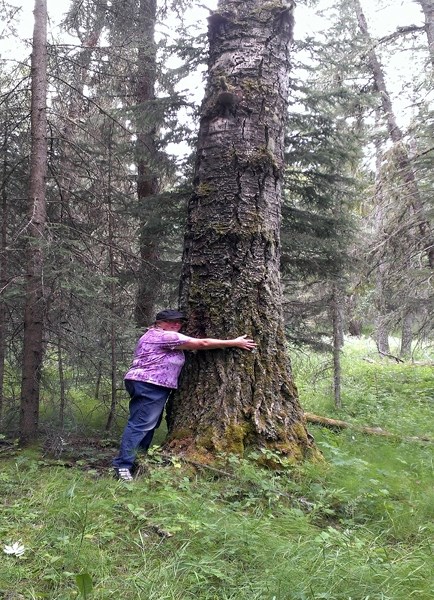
[169,0,315,458]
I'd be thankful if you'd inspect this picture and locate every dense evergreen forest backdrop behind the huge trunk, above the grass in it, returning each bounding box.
[0,1,433,440]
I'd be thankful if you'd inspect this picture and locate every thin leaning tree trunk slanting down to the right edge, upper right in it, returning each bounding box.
[353,0,434,269]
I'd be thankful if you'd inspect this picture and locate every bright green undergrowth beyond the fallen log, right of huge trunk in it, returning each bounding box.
[293,338,434,437]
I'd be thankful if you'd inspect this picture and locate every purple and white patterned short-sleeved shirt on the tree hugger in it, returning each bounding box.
[125,327,193,389]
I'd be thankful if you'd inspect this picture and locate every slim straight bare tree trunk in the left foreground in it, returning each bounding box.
[20,0,47,444]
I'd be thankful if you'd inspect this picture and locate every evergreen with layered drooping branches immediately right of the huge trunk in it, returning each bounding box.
[281,61,363,349]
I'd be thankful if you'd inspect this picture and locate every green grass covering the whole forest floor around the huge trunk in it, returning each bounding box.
[0,340,434,600]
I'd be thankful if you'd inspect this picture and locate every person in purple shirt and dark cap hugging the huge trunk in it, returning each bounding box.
[113,309,256,481]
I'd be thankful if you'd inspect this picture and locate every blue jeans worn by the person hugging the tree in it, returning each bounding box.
[113,379,172,469]
